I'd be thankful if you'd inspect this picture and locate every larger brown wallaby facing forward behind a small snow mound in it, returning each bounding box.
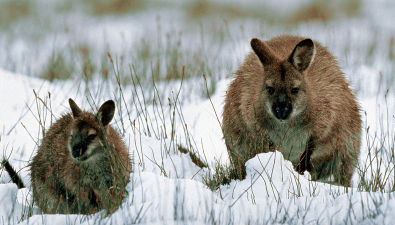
[222,36,361,186]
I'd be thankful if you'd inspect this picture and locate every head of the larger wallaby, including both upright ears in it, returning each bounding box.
[251,38,315,121]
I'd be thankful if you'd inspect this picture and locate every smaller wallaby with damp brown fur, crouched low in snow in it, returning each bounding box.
[30,98,132,214]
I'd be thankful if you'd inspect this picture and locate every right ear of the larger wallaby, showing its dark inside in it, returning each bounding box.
[288,39,314,72]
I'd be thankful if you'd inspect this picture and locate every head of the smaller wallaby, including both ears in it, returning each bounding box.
[68,98,115,161]
